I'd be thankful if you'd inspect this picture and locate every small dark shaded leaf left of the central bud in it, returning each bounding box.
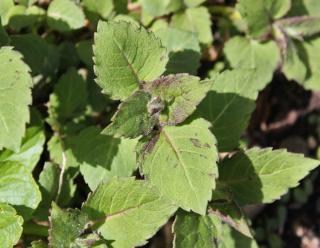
[102,91,158,138]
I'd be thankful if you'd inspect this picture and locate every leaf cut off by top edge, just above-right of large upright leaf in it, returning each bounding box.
[141,0,182,17]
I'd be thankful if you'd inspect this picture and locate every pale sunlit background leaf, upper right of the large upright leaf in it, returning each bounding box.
[171,7,213,44]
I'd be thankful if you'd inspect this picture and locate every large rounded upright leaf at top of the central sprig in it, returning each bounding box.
[93,21,168,99]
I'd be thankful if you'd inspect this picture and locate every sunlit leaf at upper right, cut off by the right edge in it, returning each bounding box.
[302,38,320,91]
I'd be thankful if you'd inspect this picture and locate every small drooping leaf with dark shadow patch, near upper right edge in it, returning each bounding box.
[282,39,308,83]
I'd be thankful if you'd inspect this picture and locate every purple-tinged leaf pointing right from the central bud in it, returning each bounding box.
[147,74,213,125]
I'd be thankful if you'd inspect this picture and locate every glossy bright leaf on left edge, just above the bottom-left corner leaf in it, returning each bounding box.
[0,161,41,216]
